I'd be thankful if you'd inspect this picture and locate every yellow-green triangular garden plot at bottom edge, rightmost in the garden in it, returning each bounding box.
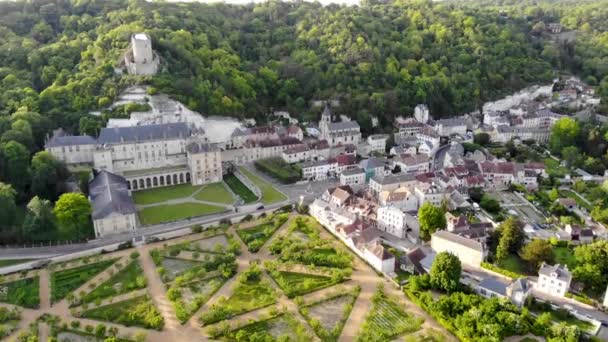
[358,293,424,341]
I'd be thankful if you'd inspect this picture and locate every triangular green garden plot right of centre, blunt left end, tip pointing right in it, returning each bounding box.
[271,271,336,298]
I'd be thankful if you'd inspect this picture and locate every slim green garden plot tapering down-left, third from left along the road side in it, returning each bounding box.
[82,260,146,303]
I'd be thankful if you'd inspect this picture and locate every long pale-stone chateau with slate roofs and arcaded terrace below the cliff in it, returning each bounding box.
[46,122,222,190]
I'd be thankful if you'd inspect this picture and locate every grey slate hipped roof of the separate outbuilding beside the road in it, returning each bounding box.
[89,171,137,220]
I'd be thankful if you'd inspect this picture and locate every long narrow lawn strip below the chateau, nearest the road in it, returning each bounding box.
[138,202,226,225]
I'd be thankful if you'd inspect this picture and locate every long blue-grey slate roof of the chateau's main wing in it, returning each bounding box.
[97,122,190,144]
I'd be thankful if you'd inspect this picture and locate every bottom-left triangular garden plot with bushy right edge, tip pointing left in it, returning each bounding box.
[82,296,164,330]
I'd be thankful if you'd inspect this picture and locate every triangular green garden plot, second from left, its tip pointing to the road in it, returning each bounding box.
[51,259,116,303]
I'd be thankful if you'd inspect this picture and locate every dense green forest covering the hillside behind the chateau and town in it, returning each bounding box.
[0,0,608,242]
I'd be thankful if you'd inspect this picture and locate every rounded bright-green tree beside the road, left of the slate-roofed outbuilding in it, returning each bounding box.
[53,192,92,240]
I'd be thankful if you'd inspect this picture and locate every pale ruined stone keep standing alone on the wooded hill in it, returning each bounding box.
[124,33,159,75]
